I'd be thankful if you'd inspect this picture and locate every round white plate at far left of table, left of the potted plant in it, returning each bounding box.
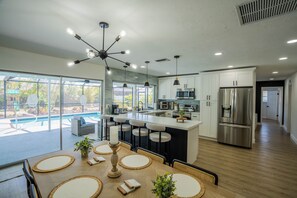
[33,155,74,172]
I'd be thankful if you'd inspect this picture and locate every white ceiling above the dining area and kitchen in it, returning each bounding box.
[0,0,297,80]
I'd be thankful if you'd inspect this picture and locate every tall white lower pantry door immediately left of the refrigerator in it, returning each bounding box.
[199,100,218,139]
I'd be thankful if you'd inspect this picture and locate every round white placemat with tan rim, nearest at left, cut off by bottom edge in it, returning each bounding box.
[48,175,103,198]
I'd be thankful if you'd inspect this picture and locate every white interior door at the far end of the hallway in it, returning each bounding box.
[266,91,278,120]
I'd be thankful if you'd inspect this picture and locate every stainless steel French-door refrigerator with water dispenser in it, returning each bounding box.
[218,87,253,148]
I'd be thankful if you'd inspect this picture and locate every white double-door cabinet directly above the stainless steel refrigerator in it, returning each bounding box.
[220,70,254,87]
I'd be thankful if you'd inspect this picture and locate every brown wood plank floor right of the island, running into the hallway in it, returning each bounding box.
[195,120,297,197]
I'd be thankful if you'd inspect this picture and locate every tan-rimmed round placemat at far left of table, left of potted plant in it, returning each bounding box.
[32,155,75,173]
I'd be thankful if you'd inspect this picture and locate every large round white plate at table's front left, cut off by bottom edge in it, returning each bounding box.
[49,176,102,198]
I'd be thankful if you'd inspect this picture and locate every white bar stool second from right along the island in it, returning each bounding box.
[129,120,148,147]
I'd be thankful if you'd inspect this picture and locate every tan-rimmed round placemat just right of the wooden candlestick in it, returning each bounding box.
[119,154,152,170]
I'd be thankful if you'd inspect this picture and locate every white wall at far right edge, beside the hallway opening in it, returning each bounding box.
[284,73,297,144]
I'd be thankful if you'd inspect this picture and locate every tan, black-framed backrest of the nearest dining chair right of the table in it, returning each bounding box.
[172,159,219,185]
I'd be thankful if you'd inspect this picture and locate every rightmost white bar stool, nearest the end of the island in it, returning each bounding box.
[146,123,171,157]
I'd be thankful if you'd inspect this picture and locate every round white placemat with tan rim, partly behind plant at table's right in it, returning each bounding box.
[173,173,205,198]
